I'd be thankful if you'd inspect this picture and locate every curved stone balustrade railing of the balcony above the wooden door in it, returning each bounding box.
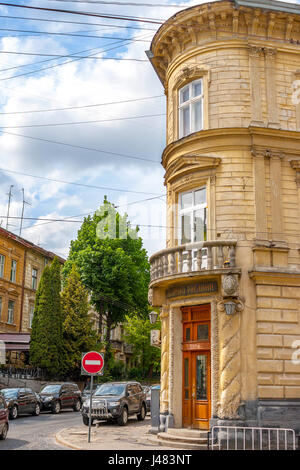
[150,240,237,281]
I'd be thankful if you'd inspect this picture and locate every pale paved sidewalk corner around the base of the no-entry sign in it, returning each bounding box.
[55,416,182,450]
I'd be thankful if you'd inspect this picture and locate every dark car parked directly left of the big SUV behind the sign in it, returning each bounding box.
[40,383,82,414]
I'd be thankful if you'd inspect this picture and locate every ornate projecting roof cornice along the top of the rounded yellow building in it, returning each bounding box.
[151,0,300,85]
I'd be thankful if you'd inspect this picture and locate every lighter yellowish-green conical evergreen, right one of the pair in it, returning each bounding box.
[61,264,99,375]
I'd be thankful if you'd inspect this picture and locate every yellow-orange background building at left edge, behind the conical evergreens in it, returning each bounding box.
[0,228,65,365]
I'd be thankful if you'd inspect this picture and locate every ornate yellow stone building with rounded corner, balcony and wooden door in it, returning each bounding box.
[147,0,300,430]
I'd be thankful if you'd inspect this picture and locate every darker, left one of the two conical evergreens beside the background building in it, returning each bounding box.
[29,258,63,377]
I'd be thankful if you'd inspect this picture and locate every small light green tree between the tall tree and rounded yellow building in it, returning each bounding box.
[123,315,161,377]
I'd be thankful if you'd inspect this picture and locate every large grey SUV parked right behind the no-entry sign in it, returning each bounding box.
[82,382,146,426]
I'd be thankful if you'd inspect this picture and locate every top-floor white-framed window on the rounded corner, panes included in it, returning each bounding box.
[179,79,203,139]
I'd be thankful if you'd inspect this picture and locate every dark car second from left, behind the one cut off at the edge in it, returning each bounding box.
[0,388,41,419]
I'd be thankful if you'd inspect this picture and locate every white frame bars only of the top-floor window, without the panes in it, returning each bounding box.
[178,77,205,139]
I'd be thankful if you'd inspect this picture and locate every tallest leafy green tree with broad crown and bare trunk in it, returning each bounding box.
[64,199,150,364]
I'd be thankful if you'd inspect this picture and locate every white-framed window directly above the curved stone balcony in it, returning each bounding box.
[179,187,207,244]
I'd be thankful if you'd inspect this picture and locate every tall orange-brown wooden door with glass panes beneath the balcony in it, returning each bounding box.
[182,305,211,429]
